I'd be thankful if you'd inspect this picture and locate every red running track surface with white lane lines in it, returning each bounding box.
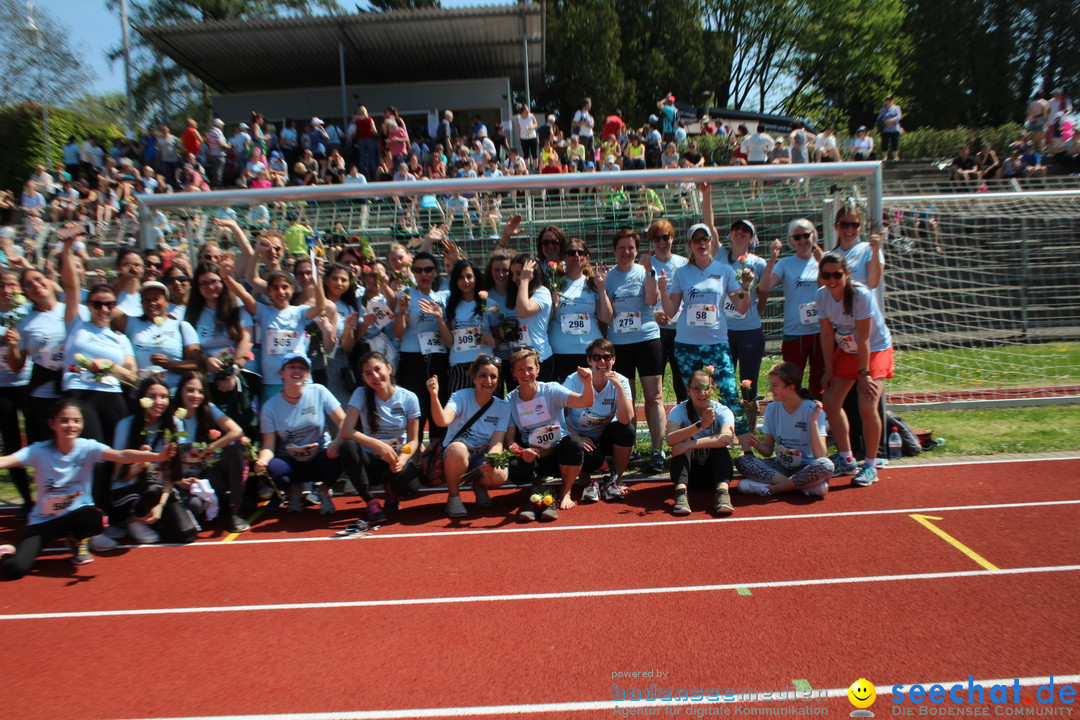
[0,462,1080,719]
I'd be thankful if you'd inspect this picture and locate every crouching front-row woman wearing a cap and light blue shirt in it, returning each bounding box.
[253,353,345,515]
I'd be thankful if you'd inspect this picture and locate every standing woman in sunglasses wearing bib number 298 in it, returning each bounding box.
[548,237,611,378]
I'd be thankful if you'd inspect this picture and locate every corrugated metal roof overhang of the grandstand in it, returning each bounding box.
[135,2,545,93]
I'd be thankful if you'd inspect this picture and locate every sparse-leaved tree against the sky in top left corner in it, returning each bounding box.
[0,0,94,106]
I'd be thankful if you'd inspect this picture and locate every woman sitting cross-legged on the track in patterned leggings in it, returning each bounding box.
[735,363,833,498]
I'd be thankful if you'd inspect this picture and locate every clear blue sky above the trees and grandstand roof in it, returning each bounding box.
[32,0,512,93]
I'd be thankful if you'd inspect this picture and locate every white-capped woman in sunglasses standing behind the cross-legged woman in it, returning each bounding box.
[759,219,825,399]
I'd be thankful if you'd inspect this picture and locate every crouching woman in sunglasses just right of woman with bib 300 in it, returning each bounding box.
[563,338,636,503]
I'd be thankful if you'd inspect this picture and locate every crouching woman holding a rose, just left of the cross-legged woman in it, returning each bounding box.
[666,367,737,515]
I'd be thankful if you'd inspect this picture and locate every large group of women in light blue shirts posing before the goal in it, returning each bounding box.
[0,197,892,576]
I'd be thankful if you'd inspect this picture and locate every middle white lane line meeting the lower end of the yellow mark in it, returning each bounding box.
[0,565,1080,621]
